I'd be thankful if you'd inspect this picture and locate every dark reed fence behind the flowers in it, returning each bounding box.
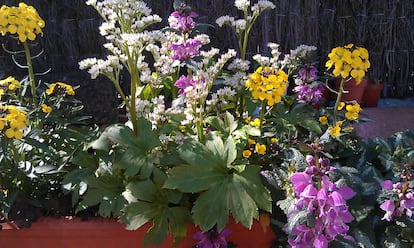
[0,0,414,123]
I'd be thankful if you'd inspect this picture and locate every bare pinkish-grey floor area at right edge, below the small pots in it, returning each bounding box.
[357,98,414,140]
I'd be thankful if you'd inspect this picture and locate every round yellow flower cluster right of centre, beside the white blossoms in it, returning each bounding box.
[246,67,288,106]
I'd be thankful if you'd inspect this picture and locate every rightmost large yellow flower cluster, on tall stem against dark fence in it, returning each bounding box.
[325,44,371,84]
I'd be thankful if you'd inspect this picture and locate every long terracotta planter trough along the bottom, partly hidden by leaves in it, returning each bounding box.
[0,218,276,248]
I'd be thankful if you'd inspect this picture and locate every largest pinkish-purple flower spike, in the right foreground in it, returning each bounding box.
[288,155,356,248]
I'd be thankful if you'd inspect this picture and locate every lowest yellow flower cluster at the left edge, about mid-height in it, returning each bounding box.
[0,105,28,139]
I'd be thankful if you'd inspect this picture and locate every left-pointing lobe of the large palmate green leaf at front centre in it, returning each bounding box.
[164,166,228,193]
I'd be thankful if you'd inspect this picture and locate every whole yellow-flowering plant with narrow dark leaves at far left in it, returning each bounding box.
[0,3,92,227]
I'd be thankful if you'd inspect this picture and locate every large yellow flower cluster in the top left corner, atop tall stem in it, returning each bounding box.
[0,3,45,42]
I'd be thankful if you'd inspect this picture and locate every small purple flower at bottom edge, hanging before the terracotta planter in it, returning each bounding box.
[194,228,231,248]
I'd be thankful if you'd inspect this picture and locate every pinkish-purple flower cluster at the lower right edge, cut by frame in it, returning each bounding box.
[380,178,414,222]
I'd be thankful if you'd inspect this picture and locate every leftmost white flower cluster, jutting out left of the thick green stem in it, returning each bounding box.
[79,55,123,79]
